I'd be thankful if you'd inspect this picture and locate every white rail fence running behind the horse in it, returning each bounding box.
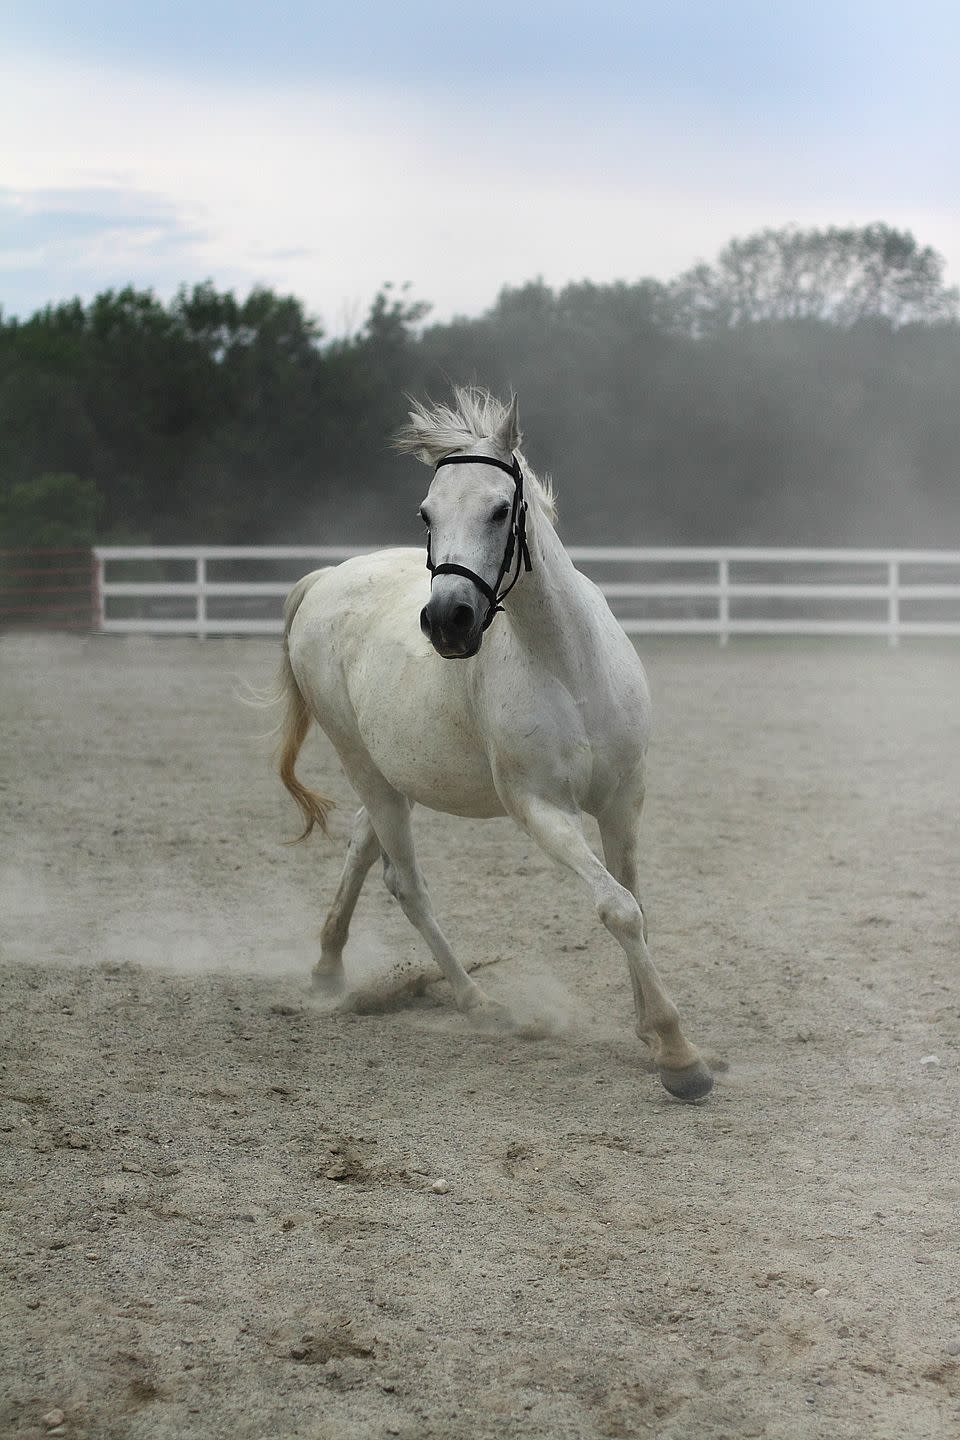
[95,546,960,645]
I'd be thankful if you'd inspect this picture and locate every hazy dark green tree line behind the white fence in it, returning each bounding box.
[0,225,960,547]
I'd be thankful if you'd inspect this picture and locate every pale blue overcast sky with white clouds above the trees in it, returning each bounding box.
[0,0,960,333]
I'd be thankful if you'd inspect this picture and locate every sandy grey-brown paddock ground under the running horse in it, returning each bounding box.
[0,638,960,1440]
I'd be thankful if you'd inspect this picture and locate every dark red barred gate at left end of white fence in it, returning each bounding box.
[0,550,99,631]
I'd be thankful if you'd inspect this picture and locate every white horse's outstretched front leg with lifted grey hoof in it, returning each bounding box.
[501,792,714,1100]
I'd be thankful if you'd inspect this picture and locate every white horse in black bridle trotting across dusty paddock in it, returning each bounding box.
[281,389,712,1100]
